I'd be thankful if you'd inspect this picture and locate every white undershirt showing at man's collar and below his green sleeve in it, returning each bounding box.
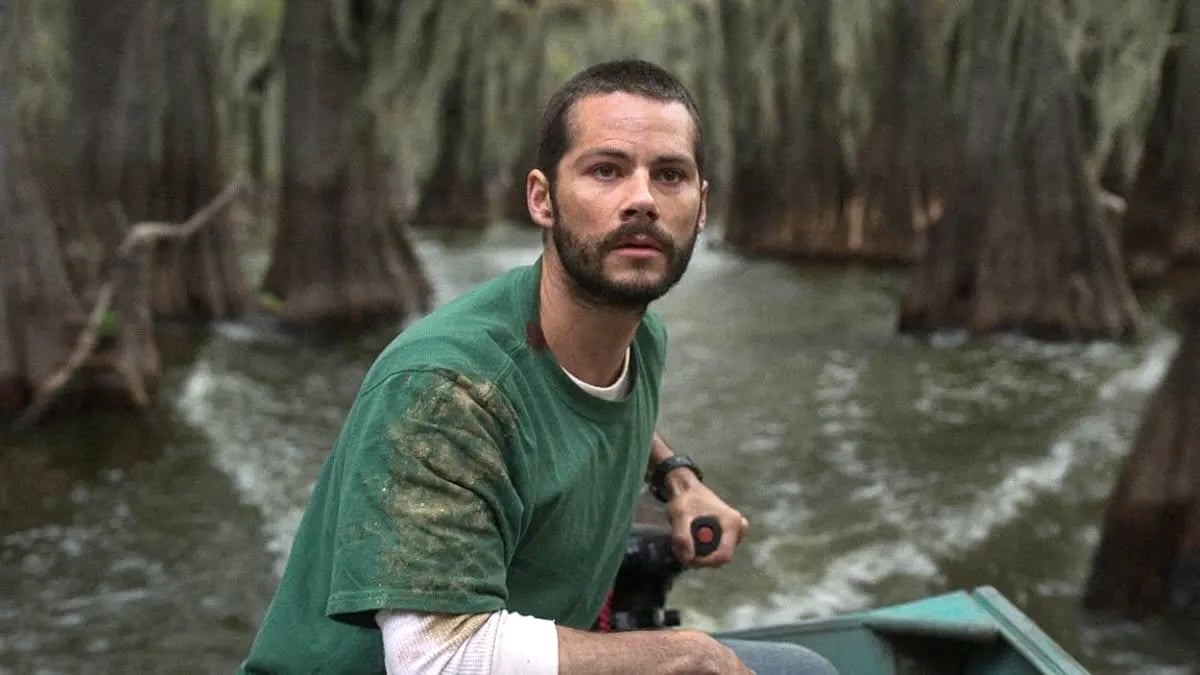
[376,348,631,675]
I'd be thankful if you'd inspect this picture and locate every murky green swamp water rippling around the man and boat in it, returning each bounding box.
[0,227,1200,675]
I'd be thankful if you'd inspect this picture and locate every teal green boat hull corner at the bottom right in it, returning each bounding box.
[719,586,1088,675]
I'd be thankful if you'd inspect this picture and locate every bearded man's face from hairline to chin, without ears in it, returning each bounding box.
[535,94,708,307]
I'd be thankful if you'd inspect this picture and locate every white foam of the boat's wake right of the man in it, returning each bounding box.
[729,329,1177,629]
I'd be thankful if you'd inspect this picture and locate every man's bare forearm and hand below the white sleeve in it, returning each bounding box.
[557,626,748,675]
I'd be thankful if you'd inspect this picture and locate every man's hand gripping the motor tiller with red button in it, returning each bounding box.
[667,468,750,567]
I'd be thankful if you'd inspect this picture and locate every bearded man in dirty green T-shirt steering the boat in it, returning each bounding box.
[242,61,832,675]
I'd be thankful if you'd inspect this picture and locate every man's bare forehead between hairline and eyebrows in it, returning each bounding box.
[568,91,695,155]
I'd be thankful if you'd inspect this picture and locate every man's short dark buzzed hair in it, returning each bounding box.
[535,60,704,183]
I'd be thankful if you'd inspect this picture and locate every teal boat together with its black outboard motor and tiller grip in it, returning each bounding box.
[609,519,1088,675]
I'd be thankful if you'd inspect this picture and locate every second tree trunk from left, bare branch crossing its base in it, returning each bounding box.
[62,0,164,405]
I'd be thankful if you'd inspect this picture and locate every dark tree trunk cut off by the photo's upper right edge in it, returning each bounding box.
[1124,1,1200,282]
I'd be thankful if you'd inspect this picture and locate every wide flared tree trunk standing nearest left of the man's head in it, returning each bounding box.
[264,0,430,323]
